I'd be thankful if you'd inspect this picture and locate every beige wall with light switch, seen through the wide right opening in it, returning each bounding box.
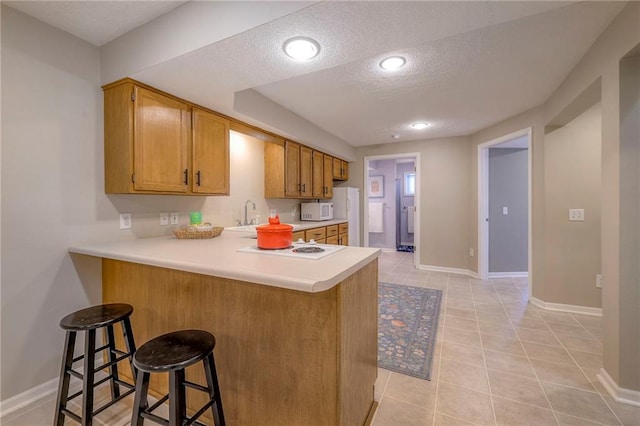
[543,103,602,308]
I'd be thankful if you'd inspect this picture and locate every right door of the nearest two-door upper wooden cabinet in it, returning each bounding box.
[191,108,229,195]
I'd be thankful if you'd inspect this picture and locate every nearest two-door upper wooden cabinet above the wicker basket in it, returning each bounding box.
[103,79,229,195]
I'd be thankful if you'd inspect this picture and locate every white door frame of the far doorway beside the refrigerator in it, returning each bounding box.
[362,152,420,267]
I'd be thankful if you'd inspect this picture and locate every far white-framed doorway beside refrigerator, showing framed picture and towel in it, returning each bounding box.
[363,153,420,266]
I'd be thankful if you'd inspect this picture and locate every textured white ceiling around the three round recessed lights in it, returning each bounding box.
[5,1,625,146]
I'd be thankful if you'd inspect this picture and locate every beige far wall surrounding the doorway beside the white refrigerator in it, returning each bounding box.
[349,138,471,270]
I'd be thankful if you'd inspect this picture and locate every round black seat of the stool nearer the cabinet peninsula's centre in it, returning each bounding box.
[133,330,216,373]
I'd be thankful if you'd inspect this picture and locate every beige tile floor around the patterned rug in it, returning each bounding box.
[5,252,640,426]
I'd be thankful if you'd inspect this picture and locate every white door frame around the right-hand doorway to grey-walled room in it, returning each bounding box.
[478,127,533,297]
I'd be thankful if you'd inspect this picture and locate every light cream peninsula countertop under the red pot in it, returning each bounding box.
[69,230,380,293]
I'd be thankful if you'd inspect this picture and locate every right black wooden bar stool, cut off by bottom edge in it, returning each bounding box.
[131,330,225,426]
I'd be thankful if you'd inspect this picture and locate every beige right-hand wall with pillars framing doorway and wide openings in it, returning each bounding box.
[470,2,640,391]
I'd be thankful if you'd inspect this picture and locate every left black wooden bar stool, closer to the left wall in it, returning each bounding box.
[54,303,136,426]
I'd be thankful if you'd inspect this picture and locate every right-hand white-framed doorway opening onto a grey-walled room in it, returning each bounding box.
[478,128,532,295]
